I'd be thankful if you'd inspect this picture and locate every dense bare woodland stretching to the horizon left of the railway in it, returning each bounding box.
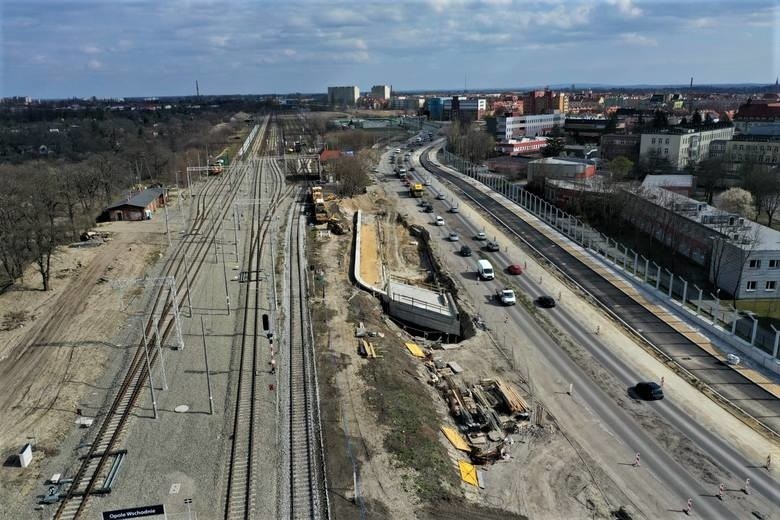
[0,107,250,290]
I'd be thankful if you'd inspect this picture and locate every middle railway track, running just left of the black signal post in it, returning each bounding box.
[225,146,291,520]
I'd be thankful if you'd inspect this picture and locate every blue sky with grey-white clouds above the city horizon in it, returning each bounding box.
[0,0,780,98]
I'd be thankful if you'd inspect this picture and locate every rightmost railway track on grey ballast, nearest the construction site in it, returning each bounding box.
[278,191,330,520]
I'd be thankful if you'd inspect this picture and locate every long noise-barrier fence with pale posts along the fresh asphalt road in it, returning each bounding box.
[441,150,780,363]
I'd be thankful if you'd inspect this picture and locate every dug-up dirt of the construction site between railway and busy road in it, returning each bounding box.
[315,187,641,519]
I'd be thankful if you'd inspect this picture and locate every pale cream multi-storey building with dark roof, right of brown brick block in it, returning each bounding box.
[639,125,734,169]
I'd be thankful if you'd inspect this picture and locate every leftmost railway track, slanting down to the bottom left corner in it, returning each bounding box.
[53,118,268,520]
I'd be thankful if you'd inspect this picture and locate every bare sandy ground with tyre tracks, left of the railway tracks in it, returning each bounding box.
[0,211,172,510]
